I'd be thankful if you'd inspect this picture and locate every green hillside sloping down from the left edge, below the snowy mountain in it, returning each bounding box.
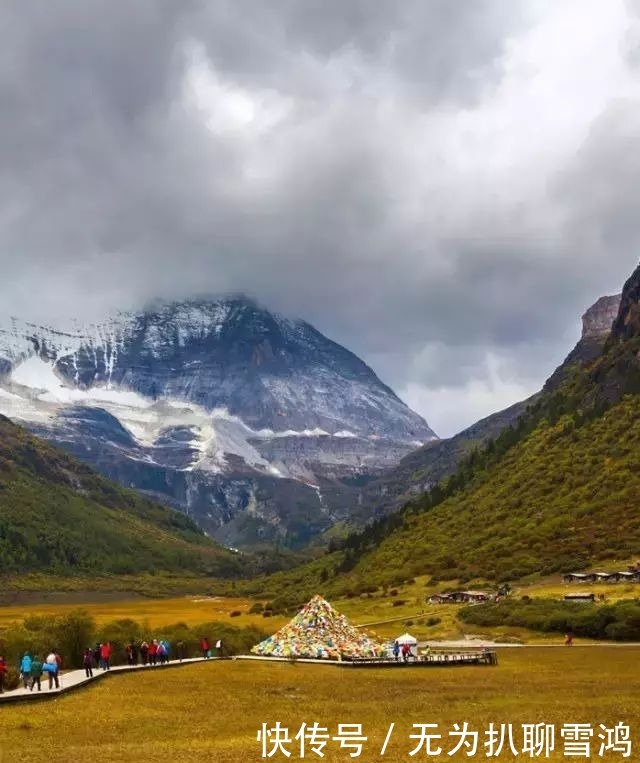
[0,417,241,576]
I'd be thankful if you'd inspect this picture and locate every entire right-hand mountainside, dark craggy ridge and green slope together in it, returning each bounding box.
[248,268,640,600]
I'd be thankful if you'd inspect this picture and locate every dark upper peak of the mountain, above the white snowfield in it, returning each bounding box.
[0,297,435,443]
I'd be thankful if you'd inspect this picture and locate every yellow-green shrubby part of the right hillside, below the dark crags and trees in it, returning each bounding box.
[352,396,640,580]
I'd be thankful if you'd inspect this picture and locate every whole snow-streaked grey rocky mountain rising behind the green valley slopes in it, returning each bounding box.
[0,297,436,547]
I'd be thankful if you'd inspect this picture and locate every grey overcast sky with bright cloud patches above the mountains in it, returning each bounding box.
[0,0,640,435]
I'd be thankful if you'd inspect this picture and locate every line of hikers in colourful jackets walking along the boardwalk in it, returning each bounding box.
[0,636,222,694]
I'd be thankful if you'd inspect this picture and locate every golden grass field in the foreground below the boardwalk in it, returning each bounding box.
[0,647,640,763]
